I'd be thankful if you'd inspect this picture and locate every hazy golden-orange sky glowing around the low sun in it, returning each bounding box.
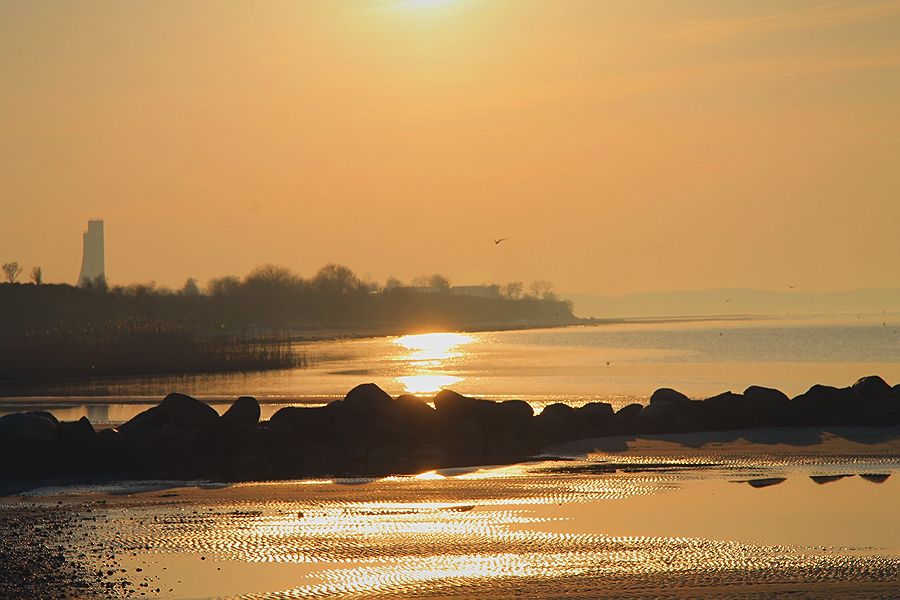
[0,0,900,295]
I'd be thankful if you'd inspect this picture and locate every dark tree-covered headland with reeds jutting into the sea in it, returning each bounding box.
[0,265,577,381]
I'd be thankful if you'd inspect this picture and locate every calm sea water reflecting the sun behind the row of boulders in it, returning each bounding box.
[0,314,900,422]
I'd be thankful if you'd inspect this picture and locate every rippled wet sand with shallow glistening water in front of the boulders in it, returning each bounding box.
[0,428,900,598]
